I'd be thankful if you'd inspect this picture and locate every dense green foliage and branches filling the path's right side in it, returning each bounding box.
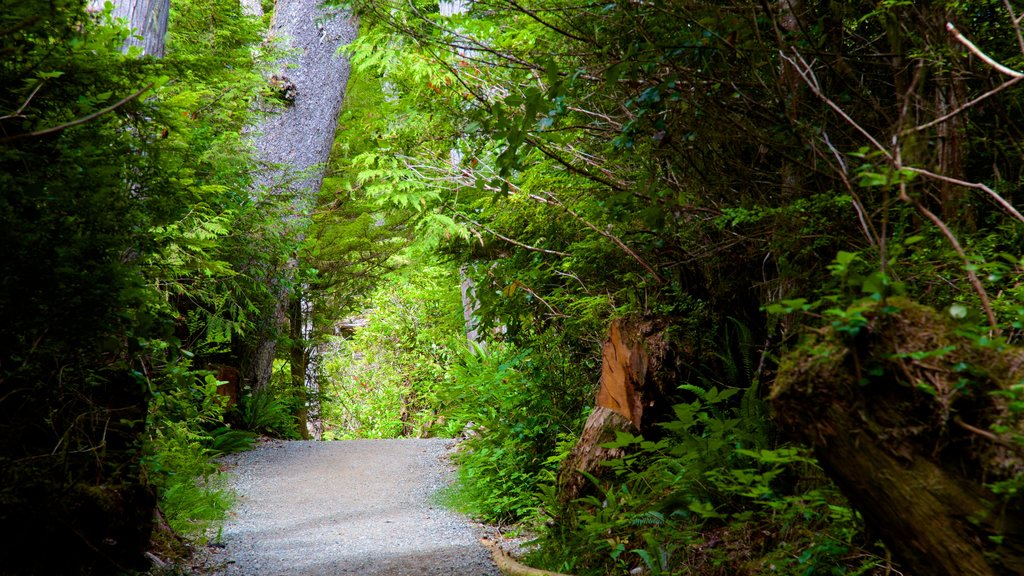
[333,0,1024,574]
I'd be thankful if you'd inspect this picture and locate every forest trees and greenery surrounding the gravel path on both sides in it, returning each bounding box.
[6,0,1024,575]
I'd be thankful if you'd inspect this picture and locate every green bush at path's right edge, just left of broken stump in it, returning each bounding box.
[440,342,589,524]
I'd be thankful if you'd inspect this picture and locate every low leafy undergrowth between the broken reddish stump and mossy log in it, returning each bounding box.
[534,386,884,575]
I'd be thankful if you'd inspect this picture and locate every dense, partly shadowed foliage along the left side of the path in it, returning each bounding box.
[0,0,295,574]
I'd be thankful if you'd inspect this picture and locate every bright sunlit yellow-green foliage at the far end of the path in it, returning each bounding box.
[322,258,466,440]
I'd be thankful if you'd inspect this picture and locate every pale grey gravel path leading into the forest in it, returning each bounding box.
[215,439,499,576]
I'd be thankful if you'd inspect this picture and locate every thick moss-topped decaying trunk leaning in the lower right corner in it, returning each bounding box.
[771,298,1024,576]
